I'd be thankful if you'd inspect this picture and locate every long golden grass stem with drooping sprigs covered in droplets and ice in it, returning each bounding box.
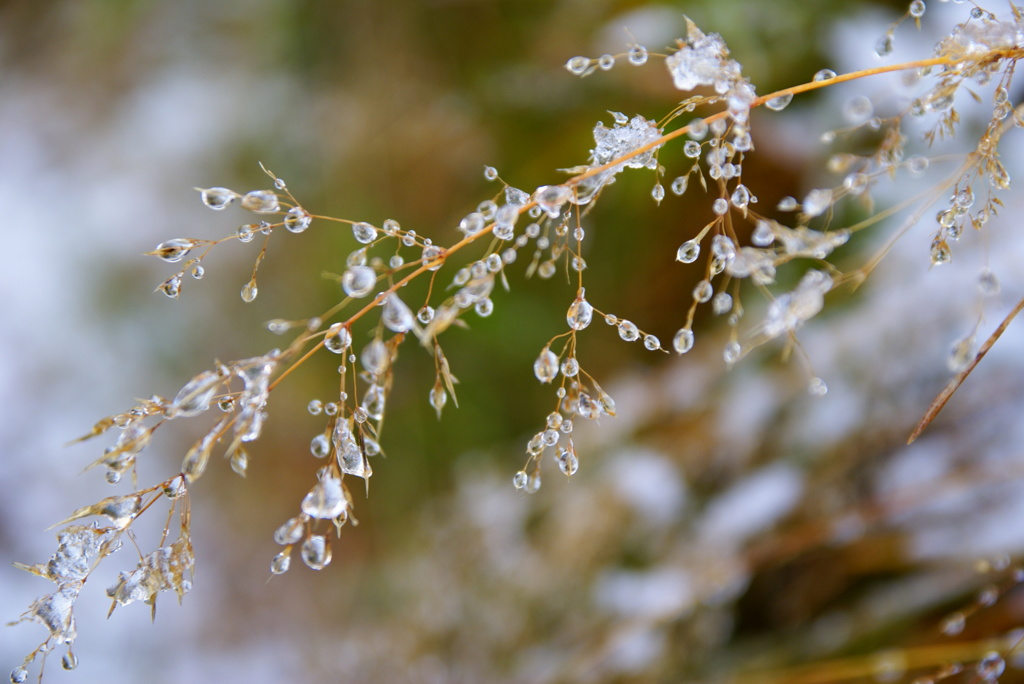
[11,0,1024,683]
